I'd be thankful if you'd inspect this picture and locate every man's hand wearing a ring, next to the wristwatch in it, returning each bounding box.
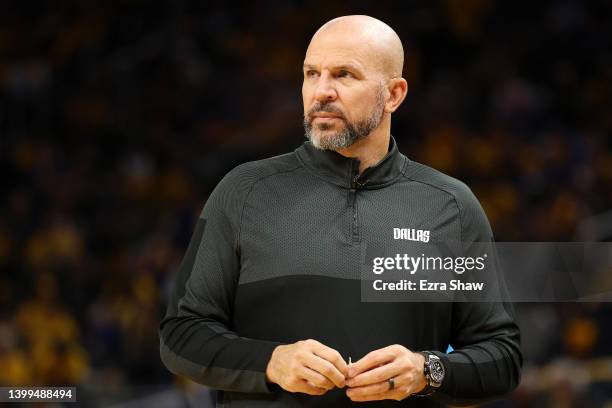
[346,344,427,401]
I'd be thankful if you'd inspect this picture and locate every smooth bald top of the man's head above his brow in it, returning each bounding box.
[306,15,404,79]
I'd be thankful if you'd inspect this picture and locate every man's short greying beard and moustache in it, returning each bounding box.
[304,87,384,150]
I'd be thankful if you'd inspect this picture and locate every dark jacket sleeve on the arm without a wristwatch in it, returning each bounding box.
[159,170,279,393]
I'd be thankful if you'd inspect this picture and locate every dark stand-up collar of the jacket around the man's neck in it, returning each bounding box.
[295,136,409,189]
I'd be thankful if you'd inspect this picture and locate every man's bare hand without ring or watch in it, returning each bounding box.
[266,340,348,395]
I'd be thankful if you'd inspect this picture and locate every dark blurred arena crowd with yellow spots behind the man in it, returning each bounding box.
[0,0,612,408]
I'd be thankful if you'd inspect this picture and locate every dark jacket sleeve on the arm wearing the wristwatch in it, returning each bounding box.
[434,187,523,405]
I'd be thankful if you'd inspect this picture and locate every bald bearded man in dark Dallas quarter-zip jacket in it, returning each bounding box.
[160,16,522,407]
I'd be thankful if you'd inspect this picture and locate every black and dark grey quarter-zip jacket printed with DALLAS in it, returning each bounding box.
[160,138,522,407]
